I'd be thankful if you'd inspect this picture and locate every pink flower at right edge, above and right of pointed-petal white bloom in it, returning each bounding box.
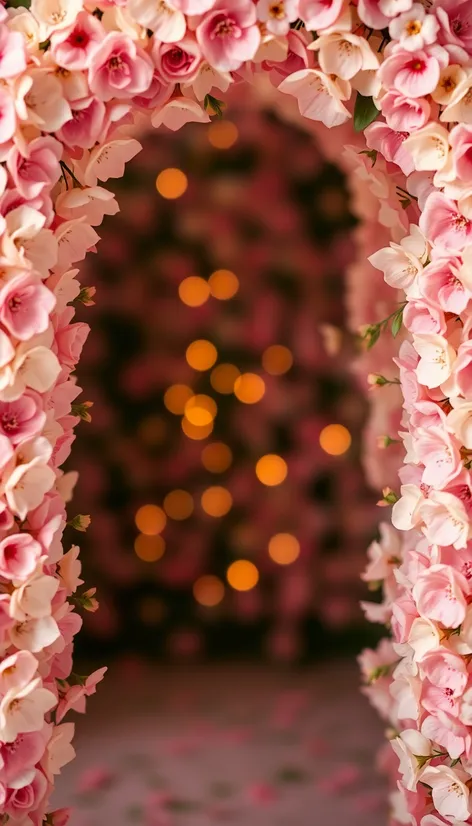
[420,191,472,254]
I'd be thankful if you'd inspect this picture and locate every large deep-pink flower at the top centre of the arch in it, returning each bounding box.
[196,0,261,72]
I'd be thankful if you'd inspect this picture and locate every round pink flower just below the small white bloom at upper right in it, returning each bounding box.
[378,49,443,98]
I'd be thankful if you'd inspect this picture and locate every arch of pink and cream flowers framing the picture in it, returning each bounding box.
[0,0,472,826]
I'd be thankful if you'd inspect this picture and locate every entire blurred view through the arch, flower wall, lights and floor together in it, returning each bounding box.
[58,90,385,826]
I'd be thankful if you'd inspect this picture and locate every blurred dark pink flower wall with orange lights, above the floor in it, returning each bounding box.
[70,96,378,660]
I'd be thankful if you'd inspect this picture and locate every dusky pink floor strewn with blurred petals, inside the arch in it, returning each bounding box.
[55,662,387,826]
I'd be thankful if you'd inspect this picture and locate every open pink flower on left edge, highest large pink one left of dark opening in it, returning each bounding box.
[0,273,56,341]
